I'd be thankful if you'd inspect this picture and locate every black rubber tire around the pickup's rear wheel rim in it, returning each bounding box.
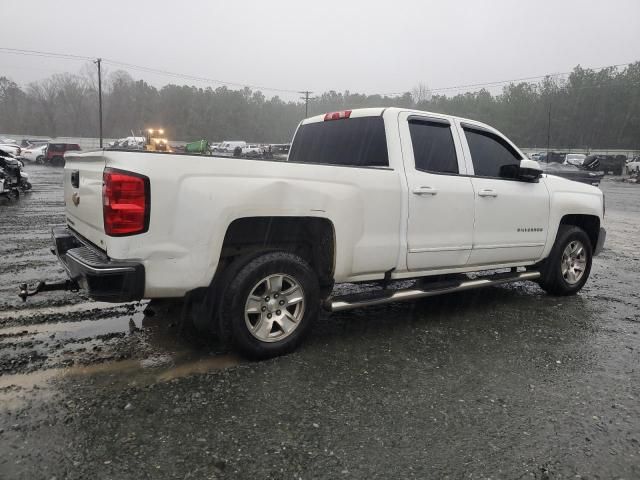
[218,251,320,359]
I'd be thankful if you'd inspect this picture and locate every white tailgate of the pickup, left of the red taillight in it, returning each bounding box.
[64,150,106,249]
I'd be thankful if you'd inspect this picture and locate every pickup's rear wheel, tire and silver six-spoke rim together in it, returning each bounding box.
[219,251,320,359]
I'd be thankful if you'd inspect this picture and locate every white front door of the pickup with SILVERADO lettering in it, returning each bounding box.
[460,123,549,265]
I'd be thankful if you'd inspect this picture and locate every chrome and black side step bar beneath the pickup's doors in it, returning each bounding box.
[323,271,540,312]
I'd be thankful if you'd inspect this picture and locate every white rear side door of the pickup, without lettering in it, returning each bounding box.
[398,112,474,271]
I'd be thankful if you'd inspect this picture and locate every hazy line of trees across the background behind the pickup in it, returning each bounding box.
[0,62,640,149]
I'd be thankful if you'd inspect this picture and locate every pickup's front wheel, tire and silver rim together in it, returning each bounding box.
[539,225,593,295]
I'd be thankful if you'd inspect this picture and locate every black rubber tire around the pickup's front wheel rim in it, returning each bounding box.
[538,225,593,296]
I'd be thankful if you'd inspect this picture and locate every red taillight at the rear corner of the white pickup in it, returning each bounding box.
[102,168,151,237]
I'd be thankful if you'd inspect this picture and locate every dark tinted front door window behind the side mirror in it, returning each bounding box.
[464,127,522,179]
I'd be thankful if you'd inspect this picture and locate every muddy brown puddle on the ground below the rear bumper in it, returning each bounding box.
[0,300,241,410]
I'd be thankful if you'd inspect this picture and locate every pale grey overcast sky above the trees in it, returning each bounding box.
[0,0,640,97]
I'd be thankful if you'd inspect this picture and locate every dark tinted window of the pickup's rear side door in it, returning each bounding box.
[409,119,459,174]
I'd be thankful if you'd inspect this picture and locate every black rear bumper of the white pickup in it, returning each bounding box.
[51,226,145,303]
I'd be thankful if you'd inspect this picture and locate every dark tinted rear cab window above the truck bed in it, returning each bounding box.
[289,117,389,167]
